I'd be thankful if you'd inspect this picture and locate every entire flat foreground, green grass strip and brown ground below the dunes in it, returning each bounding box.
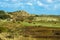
[0,21,60,40]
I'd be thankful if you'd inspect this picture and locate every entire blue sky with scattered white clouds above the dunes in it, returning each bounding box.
[0,0,60,15]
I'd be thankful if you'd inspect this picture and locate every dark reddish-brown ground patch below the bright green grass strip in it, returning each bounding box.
[23,27,60,38]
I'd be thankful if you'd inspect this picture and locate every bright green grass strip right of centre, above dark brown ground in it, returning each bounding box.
[21,22,60,27]
